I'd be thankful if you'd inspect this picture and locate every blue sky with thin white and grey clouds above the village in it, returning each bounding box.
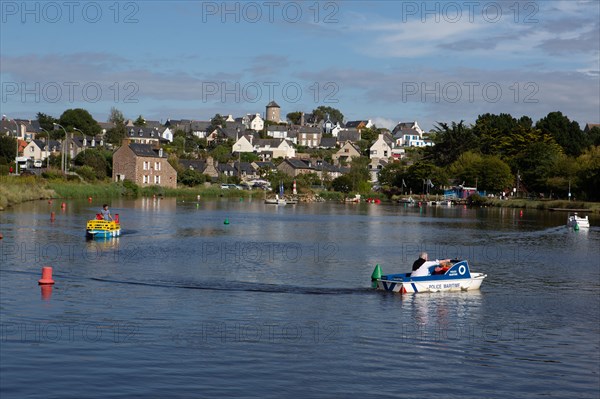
[0,0,600,131]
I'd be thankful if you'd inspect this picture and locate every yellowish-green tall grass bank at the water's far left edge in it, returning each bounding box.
[0,176,57,210]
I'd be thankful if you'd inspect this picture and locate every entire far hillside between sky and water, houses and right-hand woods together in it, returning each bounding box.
[0,101,600,199]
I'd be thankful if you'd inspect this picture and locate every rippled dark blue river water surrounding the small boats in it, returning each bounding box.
[0,198,600,399]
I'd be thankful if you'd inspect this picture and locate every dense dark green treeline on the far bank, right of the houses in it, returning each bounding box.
[379,112,600,201]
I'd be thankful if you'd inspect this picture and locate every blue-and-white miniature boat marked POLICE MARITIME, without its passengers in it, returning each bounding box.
[371,260,487,294]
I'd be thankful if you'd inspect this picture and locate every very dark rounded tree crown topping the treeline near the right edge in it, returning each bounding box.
[535,111,587,156]
